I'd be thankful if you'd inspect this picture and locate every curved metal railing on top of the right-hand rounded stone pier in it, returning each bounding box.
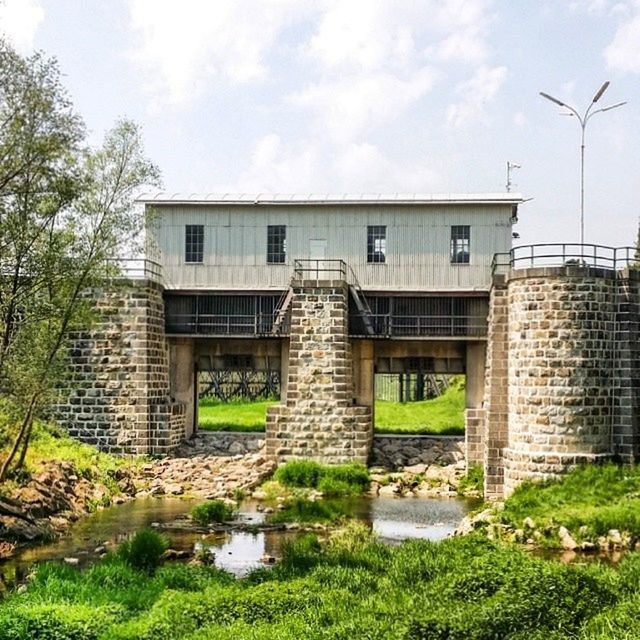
[491,242,637,274]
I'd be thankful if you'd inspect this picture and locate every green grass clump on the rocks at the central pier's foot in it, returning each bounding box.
[274,460,369,496]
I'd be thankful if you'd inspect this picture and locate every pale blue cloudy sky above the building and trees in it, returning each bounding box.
[0,0,640,246]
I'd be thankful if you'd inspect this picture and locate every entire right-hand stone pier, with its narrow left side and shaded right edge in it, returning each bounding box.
[483,265,640,496]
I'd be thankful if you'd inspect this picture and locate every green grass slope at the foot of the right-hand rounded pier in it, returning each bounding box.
[500,463,640,540]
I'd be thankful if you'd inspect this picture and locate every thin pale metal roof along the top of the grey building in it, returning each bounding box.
[136,192,523,206]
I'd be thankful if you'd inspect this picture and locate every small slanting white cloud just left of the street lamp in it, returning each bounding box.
[447,66,507,128]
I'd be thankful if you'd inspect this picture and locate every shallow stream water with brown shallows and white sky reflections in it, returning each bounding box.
[0,498,474,591]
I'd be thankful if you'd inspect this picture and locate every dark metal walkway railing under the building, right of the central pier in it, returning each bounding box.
[349,313,487,338]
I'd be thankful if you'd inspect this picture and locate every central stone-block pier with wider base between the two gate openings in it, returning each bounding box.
[266,281,373,463]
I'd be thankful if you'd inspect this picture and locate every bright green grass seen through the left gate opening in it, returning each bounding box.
[198,398,276,431]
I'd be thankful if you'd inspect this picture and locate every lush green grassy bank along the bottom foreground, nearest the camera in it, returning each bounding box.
[0,528,640,640]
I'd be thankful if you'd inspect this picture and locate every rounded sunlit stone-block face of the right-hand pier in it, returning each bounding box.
[504,267,617,494]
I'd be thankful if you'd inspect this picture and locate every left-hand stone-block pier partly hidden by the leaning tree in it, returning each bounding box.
[55,280,185,454]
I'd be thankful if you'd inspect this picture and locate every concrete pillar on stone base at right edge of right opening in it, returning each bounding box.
[464,342,486,465]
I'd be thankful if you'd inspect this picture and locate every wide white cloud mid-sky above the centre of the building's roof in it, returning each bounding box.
[288,67,434,141]
